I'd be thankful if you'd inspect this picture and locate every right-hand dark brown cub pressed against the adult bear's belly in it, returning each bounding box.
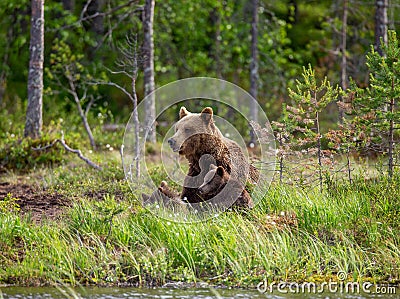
[199,164,254,208]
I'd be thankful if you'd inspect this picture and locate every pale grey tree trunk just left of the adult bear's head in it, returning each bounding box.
[143,0,156,143]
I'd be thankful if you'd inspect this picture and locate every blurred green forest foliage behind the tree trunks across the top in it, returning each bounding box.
[0,0,400,137]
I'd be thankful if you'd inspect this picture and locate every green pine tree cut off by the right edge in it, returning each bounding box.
[350,31,400,177]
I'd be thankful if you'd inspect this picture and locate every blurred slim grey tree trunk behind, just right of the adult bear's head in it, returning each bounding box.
[250,0,258,146]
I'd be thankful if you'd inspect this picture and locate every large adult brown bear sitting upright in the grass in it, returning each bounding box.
[163,107,259,203]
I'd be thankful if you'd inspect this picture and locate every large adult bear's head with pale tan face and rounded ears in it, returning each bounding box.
[168,107,222,155]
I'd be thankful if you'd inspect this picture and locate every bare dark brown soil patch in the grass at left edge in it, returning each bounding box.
[0,182,69,222]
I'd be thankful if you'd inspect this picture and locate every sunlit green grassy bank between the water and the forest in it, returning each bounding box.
[0,157,400,287]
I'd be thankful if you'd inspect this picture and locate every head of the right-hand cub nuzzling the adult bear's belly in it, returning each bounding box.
[199,164,230,195]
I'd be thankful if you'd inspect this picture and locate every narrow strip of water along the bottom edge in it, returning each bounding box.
[0,287,400,299]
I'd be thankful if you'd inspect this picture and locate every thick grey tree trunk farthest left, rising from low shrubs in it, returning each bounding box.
[24,0,44,138]
